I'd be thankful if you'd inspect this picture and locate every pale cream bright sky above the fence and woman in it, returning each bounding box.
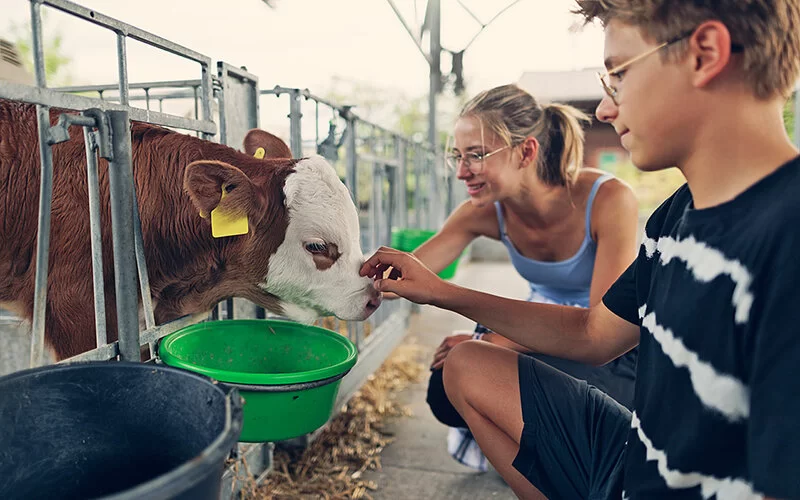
[0,0,602,95]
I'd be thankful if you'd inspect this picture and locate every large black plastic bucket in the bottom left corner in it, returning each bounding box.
[0,362,242,500]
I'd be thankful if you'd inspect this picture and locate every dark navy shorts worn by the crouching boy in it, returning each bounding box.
[513,356,631,500]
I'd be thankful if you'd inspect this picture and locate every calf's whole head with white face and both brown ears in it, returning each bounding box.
[184,130,380,322]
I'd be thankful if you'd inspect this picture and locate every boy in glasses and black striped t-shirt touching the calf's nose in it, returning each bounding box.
[362,0,800,500]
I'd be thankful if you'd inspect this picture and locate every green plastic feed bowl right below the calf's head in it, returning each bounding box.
[158,319,358,442]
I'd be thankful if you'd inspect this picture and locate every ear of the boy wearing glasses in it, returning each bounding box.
[689,21,731,88]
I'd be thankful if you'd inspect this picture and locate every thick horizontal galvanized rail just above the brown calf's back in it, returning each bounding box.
[0,82,217,136]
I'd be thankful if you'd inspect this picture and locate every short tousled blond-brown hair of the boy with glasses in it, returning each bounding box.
[573,0,800,99]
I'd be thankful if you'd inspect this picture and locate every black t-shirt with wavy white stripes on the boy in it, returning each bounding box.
[603,157,800,500]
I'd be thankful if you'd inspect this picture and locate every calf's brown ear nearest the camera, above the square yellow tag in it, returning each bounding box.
[183,160,266,223]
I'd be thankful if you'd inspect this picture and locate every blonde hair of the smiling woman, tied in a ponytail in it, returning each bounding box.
[459,85,590,187]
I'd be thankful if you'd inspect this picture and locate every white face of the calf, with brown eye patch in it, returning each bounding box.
[260,156,380,322]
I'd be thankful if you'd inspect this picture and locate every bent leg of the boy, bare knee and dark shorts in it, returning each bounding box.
[444,342,630,500]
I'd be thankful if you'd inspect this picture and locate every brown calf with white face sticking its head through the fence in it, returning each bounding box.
[0,100,380,360]
